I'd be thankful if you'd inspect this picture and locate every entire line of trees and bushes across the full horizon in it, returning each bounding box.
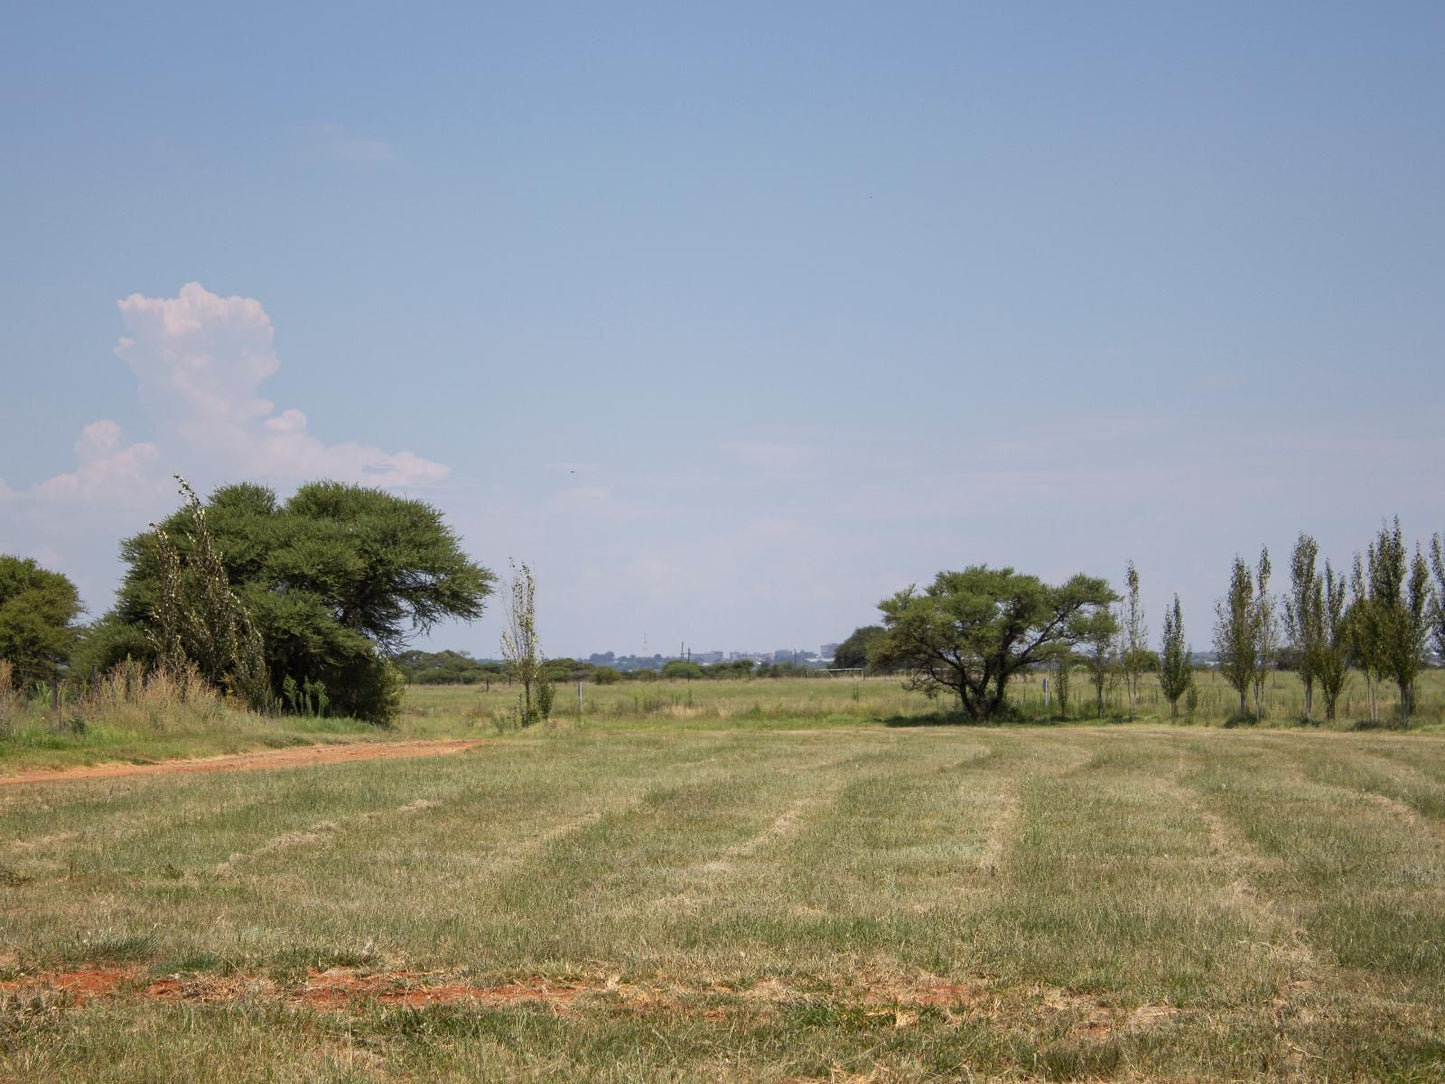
[0,480,1445,726]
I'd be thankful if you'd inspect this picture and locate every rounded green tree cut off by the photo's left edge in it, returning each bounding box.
[0,554,81,689]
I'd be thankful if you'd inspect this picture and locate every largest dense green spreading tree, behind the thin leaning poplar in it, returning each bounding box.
[91,481,493,723]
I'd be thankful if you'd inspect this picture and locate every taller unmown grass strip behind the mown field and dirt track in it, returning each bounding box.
[0,669,1445,776]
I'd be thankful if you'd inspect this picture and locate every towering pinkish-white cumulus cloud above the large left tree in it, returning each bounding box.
[0,282,448,613]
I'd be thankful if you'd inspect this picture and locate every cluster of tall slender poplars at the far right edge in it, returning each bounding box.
[1214,517,1445,726]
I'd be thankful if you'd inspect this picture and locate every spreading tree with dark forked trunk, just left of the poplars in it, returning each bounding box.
[868,565,1117,720]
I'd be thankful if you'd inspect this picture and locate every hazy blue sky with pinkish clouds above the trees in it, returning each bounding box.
[0,3,1445,655]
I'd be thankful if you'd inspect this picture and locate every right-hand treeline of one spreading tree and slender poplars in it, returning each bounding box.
[834,517,1445,726]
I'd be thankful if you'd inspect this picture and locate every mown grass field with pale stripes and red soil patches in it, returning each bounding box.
[0,682,1445,1081]
